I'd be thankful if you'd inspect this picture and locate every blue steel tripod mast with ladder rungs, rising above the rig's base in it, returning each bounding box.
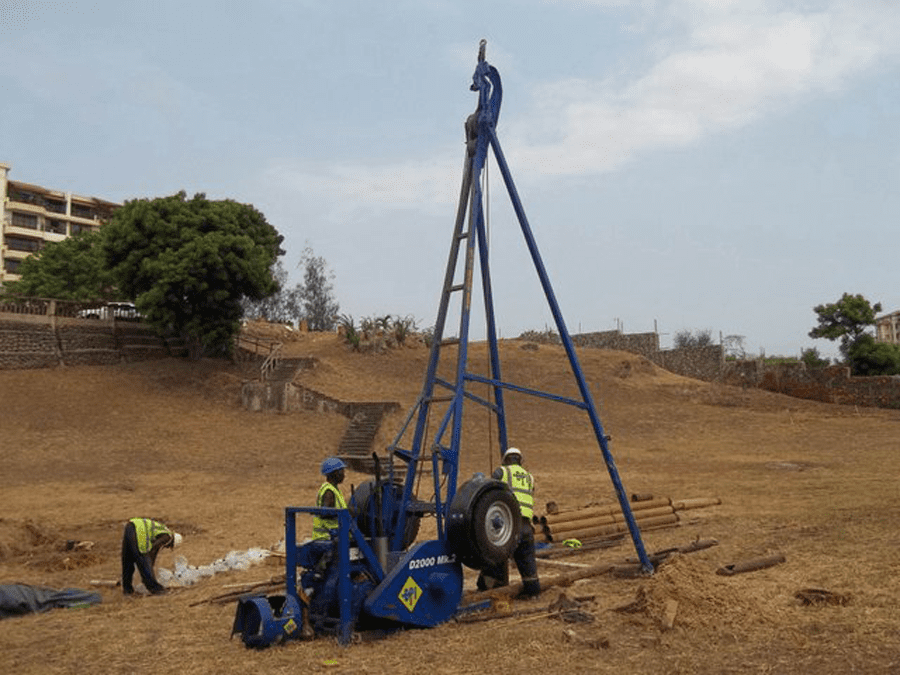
[390,40,653,572]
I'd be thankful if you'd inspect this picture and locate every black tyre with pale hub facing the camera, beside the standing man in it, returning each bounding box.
[468,488,522,569]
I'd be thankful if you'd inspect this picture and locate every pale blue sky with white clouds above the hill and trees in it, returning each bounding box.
[0,0,900,356]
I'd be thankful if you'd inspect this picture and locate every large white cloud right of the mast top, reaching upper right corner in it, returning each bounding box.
[514,0,900,175]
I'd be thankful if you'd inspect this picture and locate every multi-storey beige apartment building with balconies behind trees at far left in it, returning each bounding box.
[0,163,121,285]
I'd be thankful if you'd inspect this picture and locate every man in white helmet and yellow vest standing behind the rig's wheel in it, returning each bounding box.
[478,448,541,599]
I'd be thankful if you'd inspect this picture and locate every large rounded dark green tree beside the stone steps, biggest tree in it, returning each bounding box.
[102,192,284,358]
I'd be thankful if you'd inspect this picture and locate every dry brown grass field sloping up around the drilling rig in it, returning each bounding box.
[0,326,900,675]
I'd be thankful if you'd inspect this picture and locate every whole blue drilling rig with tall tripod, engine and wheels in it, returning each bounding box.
[233,40,653,647]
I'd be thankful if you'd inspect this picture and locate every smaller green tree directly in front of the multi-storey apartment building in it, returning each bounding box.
[6,232,118,301]
